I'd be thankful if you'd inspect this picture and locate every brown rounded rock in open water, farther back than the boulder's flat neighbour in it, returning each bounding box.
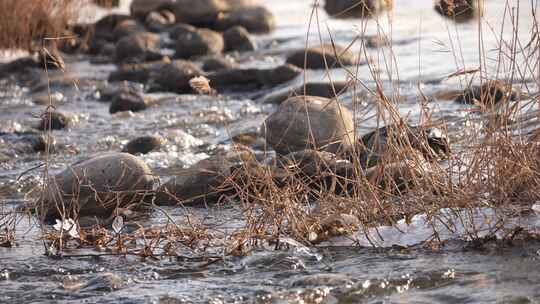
[287,44,357,70]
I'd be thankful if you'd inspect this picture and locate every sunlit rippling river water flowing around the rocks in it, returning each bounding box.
[0,0,540,303]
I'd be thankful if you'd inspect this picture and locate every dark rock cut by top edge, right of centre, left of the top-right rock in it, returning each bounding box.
[324,0,393,18]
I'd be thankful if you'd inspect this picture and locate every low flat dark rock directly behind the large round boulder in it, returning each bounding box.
[264,82,349,104]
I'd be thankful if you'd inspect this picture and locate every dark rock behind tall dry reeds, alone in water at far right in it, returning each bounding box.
[455,80,524,105]
